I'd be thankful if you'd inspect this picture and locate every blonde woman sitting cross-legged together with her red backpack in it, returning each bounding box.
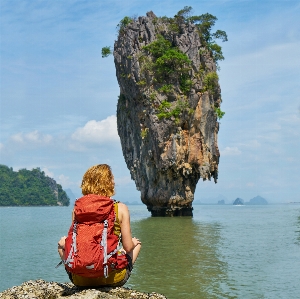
[58,164,141,287]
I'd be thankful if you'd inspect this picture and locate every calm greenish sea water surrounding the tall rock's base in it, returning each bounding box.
[0,204,300,299]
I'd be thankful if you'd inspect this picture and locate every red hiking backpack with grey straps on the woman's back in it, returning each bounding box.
[64,194,128,277]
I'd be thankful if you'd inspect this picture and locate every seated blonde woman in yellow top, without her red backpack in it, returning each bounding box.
[58,164,141,287]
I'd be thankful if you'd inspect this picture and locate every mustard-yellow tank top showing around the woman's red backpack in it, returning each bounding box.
[72,202,126,287]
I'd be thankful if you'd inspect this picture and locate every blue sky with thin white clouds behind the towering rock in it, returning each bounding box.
[0,0,300,203]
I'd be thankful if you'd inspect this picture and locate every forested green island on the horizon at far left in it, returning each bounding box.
[0,165,70,206]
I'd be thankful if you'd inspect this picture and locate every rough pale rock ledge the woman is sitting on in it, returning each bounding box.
[0,280,167,299]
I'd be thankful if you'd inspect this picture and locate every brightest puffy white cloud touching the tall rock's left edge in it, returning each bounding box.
[72,115,119,144]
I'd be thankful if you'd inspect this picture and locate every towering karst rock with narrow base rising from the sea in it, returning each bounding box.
[102,7,227,216]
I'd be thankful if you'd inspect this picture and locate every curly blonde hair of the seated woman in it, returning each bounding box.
[81,164,115,197]
